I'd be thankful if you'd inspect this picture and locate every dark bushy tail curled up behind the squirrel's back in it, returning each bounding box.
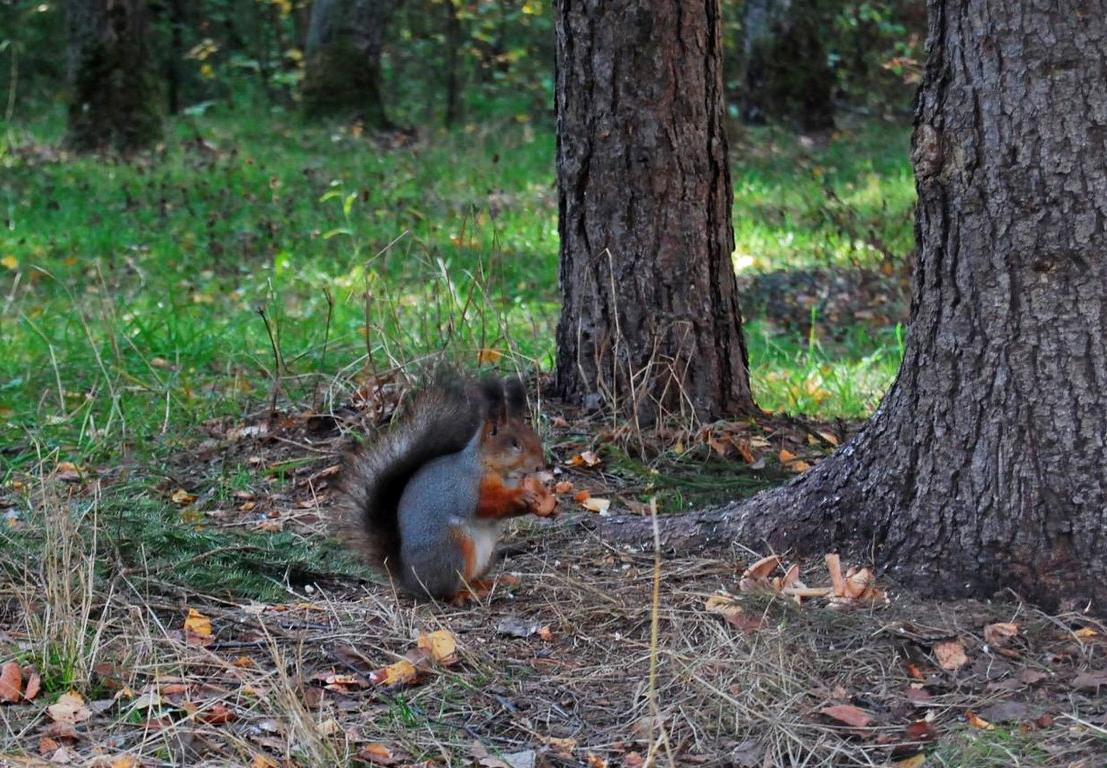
[338,380,487,572]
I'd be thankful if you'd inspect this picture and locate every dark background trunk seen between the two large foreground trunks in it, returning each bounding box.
[742,0,834,131]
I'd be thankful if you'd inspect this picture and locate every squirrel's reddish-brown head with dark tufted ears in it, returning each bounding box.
[480,377,546,475]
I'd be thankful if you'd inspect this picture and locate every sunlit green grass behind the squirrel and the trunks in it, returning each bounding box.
[0,111,913,596]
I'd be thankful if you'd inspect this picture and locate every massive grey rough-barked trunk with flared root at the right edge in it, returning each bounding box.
[611,0,1107,613]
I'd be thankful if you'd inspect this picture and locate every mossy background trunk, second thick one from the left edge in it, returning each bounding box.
[303,0,399,128]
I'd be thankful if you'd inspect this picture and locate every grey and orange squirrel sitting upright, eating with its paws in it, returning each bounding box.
[340,377,557,602]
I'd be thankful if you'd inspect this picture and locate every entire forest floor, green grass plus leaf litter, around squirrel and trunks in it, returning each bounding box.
[0,109,1107,768]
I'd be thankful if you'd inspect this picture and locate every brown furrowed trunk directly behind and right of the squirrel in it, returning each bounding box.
[557,0,754,424]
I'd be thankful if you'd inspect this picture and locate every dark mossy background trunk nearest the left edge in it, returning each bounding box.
[66,0,162,152]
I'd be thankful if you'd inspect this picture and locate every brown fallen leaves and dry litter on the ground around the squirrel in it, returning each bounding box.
[0,380,1107,768]
